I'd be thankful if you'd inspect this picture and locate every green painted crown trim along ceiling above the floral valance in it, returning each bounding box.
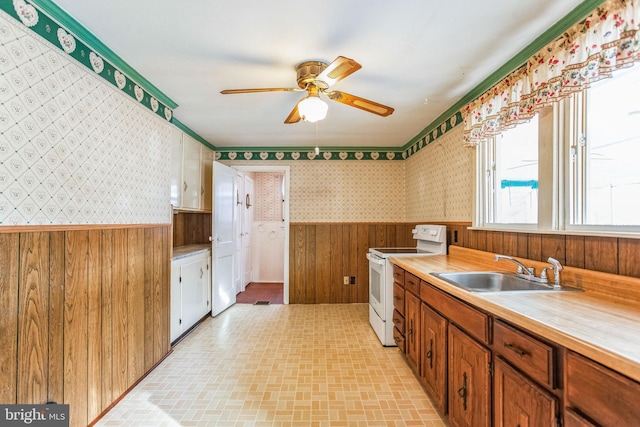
[402,0,605,150]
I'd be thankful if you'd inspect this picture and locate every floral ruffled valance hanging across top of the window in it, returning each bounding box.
[462,0,640,145]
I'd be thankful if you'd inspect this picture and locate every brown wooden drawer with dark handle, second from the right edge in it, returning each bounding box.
[493,320,555,388]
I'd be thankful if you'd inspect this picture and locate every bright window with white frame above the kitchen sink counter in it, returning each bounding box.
[474,65,640,232]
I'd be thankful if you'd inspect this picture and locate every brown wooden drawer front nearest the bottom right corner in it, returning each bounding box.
[565,352,640,427]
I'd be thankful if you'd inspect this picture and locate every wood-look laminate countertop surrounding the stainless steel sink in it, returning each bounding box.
[391,249,640,381]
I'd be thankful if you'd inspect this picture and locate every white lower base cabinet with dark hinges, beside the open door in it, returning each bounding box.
[171,251,211,342]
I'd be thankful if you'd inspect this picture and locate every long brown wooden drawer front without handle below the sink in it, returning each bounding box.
[420,280,489,344]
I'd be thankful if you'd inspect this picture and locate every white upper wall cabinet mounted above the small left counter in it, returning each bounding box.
[171,132,214,212]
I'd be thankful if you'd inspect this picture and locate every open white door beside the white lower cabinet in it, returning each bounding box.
[211,162,236,316]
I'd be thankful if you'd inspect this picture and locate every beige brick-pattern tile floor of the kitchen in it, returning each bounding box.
[97,304,446,427]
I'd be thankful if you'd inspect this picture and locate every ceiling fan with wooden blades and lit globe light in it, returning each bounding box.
[220,56,393,124]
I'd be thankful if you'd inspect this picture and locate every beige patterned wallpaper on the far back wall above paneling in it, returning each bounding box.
[223,160,405,222]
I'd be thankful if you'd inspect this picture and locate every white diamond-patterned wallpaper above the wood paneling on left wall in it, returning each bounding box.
[0,12,172,225]
